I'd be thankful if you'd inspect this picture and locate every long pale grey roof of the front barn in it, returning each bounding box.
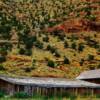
[0,75,100,88]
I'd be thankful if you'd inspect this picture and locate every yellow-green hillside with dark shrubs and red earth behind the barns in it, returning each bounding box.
[0,0,100,78]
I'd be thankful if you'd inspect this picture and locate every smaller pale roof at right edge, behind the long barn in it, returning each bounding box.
[76,69,100,79]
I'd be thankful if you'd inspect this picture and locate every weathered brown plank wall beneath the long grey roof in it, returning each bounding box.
[0,80,100,96]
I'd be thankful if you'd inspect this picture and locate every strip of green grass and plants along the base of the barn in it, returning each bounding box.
[0,92,100,100]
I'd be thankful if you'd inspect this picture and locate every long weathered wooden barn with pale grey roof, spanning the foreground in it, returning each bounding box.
[0,75,100,95]
